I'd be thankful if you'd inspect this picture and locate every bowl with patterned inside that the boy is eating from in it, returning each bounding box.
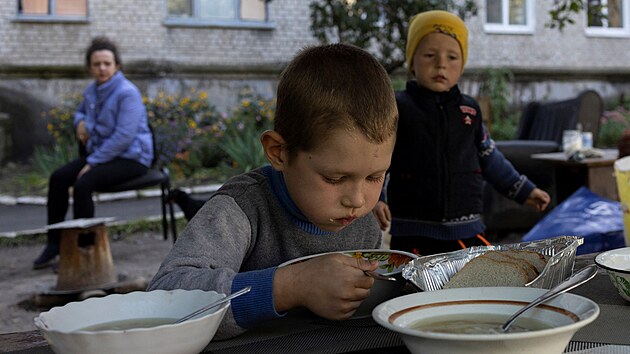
[279,249,418,318]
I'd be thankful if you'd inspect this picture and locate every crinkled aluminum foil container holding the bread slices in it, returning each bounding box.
[402,236,584,291]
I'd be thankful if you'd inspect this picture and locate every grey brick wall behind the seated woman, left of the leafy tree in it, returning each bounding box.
[0,0,315,66]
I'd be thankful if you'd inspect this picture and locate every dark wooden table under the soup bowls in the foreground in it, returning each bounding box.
[0,254,630,354]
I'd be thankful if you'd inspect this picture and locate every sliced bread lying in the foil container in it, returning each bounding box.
[444,250,547,289]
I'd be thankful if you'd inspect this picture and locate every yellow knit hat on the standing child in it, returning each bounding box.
[405,10,468,71]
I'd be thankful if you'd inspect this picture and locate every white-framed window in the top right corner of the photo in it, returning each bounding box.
[586,0,630,37]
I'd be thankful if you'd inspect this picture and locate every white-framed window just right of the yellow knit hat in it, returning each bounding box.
[484,0,534,33]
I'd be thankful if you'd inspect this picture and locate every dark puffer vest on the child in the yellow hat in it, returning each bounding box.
[387,81,484,222]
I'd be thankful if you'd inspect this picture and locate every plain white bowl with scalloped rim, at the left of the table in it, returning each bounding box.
[35,290,230,354]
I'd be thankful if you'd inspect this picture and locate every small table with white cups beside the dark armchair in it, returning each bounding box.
[531,149,619,203]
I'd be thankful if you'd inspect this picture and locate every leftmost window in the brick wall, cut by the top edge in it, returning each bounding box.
[18,0,87,20]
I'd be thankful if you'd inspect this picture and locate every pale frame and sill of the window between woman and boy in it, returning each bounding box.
[162,0,276,30]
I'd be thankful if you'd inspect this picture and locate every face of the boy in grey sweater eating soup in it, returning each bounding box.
[282,129,394,232]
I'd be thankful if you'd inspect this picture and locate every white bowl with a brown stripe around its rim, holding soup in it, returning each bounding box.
[372,287,599,354]
